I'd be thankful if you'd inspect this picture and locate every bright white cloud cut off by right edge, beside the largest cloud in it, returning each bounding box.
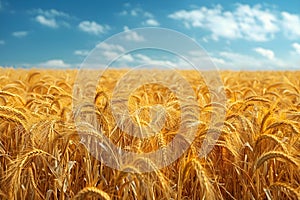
[281,12,300,39]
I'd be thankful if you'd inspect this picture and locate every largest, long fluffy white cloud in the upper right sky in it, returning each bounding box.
[168,4,279,41]
